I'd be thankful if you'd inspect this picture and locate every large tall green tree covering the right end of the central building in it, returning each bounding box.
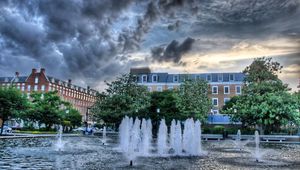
[222,58,299,134]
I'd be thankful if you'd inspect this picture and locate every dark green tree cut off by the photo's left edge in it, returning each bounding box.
[0,87,28,135]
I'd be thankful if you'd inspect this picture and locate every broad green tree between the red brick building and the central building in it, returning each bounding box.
[91,74,150,124]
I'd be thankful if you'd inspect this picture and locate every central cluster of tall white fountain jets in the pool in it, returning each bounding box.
[119,116,203,165]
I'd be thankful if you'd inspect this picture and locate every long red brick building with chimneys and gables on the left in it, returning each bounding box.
[0,68,97,121]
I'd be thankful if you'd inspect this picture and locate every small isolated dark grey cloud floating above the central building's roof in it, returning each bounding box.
[151,37,195,63]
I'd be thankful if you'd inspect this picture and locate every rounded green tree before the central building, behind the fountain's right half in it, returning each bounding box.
[176,79,212,121]
